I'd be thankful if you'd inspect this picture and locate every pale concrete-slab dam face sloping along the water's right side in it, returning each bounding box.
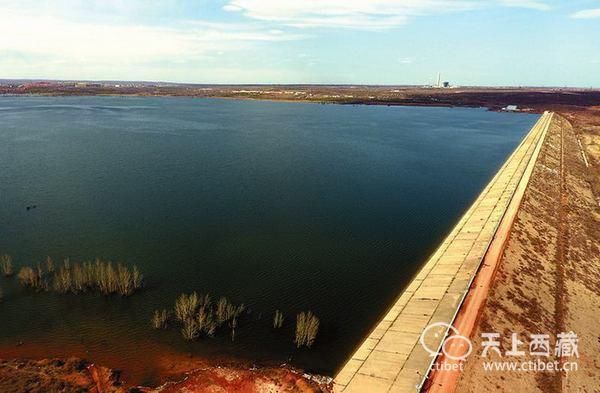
[335,112,552,393]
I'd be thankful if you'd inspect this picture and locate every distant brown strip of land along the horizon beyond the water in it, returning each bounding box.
[0,80,600,112]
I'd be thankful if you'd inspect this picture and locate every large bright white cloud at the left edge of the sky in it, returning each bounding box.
[0,8,302,65]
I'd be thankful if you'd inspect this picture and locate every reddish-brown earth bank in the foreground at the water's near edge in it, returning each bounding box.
[0,358,332,393]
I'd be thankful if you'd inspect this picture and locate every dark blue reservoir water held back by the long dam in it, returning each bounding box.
[0,97,537,383]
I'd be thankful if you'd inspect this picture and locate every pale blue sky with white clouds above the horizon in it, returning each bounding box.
[0,0,600,87]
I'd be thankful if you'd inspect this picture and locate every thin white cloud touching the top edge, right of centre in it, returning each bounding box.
[223,0,550,30]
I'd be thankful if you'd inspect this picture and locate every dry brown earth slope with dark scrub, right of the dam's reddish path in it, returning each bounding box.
[456,108,600,393]
